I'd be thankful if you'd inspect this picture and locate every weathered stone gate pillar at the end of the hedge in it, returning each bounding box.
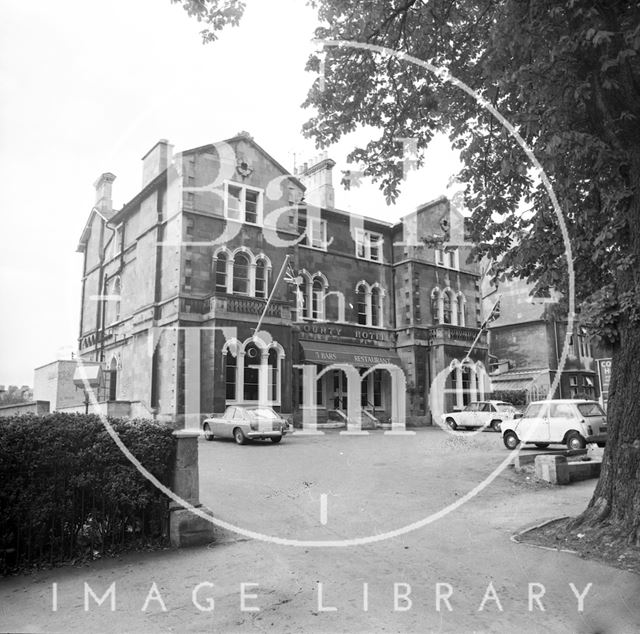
[169,429,215,548]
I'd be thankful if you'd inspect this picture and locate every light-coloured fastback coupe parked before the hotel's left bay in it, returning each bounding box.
[202,405,289,445]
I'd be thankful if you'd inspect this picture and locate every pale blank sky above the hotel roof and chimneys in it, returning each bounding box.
[0,0,459,385]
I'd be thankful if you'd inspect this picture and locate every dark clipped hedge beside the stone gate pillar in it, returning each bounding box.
[0,413,176,574]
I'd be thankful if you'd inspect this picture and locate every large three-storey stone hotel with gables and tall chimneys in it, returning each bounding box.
[78,133,487,424]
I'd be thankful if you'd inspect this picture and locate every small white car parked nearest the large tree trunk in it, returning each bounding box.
[502,399,607,449]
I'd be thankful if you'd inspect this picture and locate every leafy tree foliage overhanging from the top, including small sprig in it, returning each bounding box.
[172,0,640,341]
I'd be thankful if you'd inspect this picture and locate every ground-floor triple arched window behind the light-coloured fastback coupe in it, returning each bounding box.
[222,337,284,405]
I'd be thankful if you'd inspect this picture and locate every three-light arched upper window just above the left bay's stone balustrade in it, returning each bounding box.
[213,247,271,298]
